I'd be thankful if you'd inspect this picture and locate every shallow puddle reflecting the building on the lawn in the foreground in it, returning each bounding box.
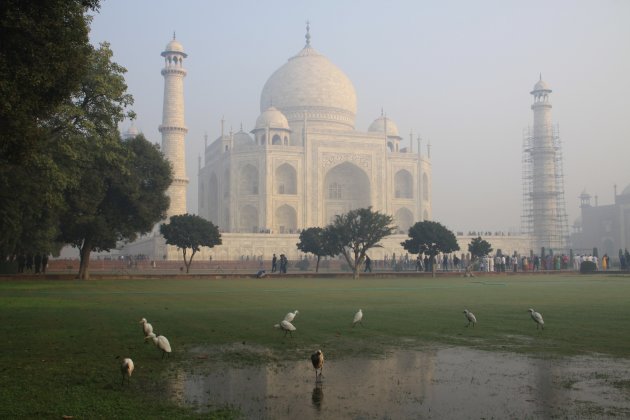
[170,348,630,420]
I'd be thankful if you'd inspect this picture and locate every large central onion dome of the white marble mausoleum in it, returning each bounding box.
[260,42,357,129]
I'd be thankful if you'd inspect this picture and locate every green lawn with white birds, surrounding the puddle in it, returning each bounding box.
[0,275,630,419]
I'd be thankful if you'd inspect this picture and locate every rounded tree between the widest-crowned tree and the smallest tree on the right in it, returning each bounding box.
[400,220,459,275]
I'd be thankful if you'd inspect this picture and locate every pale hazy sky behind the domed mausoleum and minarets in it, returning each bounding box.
[91,0,630,231]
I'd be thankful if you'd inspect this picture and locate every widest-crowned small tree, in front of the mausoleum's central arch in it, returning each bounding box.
[326,207,397,279]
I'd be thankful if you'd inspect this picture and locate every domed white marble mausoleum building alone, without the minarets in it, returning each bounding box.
[198,28,431,246]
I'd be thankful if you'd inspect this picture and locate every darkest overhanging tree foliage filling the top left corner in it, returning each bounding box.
[0,0,100,165]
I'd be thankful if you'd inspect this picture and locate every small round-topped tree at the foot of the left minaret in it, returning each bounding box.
[160,214,221,273]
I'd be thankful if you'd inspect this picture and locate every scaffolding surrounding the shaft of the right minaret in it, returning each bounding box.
[521,125,569,253]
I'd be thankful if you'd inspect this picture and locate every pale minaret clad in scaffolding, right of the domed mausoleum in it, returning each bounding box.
[529,75,566,252]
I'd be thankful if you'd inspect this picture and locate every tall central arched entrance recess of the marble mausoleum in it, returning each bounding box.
[324,162,372,223]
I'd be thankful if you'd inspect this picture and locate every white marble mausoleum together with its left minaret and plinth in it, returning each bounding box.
[125,25,544,260]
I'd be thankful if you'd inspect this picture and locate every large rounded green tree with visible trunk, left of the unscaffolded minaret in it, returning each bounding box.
[60,135,172,279]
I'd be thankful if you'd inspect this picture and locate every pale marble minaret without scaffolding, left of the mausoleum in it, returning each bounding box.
[159,33,188,217]
